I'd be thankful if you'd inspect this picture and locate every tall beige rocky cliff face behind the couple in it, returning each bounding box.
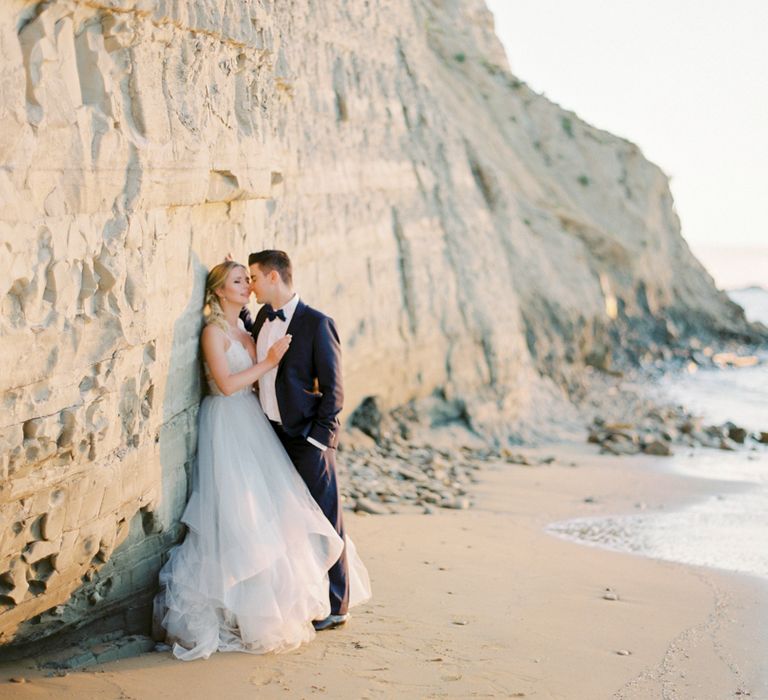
[0,0,749,643]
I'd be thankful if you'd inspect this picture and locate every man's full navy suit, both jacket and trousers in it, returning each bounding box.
[240,300,349,615]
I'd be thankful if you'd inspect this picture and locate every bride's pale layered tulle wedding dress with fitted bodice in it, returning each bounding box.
[155,339,370,660]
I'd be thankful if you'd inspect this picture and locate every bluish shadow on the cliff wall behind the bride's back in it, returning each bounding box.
[3,251,207,667]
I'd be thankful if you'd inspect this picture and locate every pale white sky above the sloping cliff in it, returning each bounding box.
[487,0,768,258]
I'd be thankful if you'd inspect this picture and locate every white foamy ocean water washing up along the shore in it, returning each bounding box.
[548,287,768,579]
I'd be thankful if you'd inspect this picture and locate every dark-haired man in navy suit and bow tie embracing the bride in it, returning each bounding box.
[240,250,349,630]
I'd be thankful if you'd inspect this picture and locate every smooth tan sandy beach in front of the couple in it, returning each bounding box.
[0,445,768,700]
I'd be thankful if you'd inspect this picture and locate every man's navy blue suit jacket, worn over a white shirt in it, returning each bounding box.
[240,299,344,448]
